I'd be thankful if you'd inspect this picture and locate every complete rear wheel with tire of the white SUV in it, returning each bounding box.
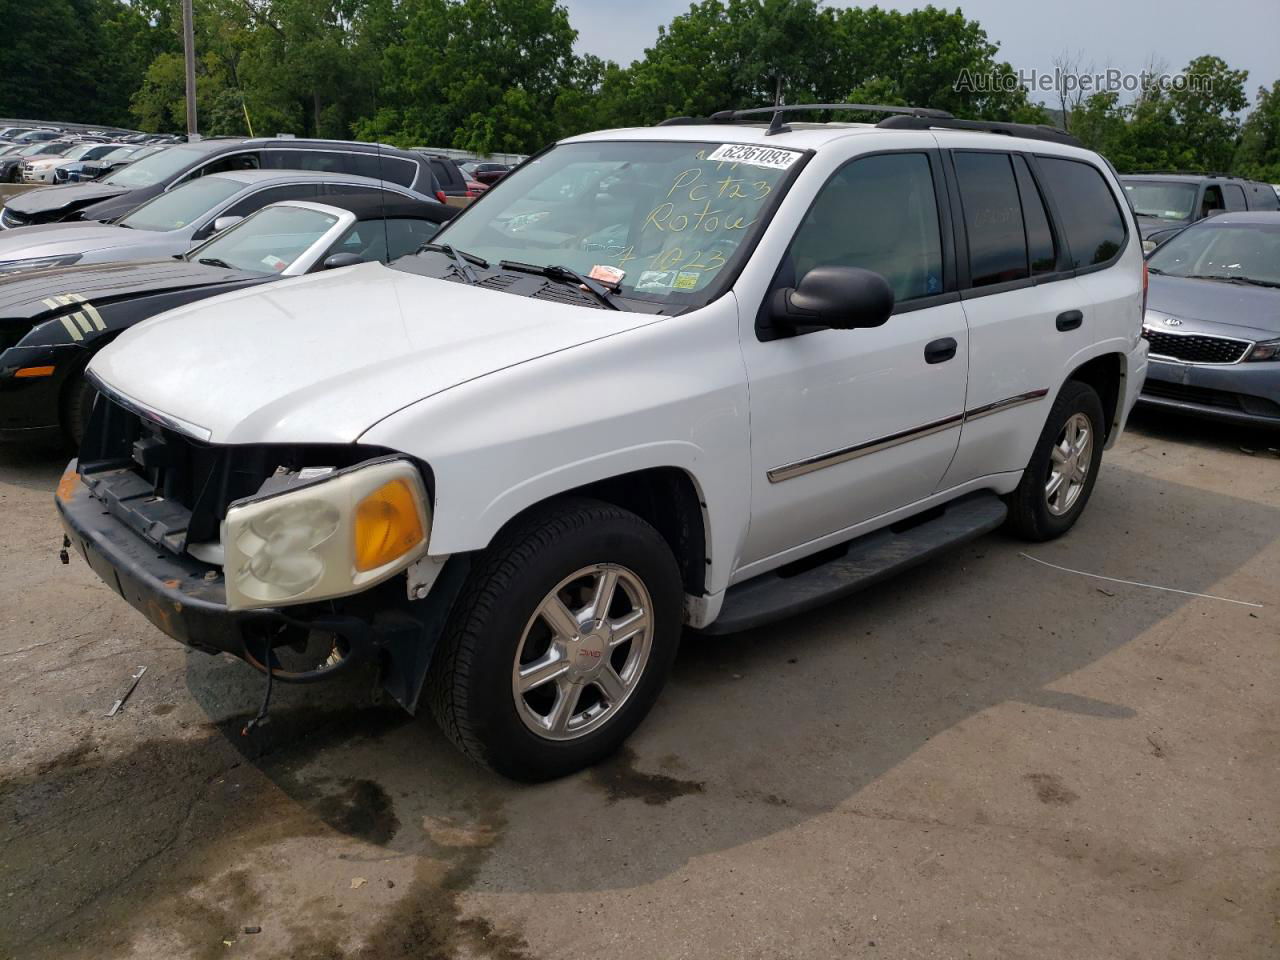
[1006,380,1106,541]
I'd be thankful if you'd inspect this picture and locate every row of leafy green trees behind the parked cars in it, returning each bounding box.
[0,0,1280,180]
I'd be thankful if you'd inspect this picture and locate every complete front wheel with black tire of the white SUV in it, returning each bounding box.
[428,498,684,781]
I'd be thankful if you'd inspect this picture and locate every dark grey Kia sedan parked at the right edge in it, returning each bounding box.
[1140,212,1280,429]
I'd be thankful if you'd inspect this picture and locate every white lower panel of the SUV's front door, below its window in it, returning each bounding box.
[742,303,966,563]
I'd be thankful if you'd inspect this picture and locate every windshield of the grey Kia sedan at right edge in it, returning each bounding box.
[1147,223,1280,285]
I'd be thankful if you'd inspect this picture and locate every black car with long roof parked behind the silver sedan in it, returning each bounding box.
[0,137,450,228]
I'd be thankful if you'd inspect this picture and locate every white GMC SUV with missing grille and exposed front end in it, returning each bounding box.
[51,106,1147,780]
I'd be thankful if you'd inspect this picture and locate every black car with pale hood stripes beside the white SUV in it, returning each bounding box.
[0,191,458,443]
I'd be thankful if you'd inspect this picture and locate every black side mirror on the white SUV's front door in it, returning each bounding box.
[769,266,893,333]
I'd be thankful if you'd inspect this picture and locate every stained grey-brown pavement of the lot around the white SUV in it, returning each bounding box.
[0,407,1280,960]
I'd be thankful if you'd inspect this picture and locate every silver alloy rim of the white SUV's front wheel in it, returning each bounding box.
[511,563,653,740]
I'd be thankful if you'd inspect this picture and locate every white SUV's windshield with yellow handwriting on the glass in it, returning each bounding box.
[436,141,803,306]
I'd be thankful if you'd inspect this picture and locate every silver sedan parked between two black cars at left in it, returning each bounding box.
[0,170,430,273]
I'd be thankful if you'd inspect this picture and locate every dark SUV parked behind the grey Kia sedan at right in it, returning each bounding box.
[1120,173,1280,253]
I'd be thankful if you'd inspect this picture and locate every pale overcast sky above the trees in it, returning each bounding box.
[562,0,1280,106]
